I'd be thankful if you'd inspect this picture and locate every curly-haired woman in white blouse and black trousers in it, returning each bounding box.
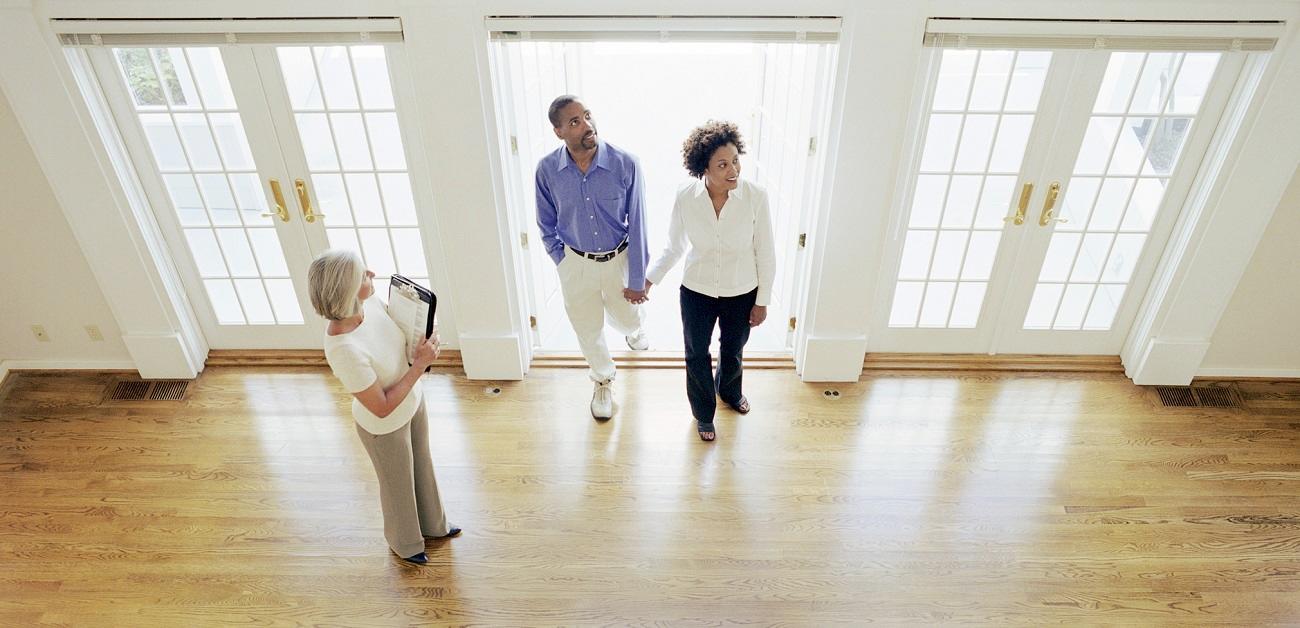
[646,120,776,441]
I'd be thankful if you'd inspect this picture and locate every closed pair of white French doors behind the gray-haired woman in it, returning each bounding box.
[87,44,441,348]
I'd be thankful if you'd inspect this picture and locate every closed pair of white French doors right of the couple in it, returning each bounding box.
[870,48,1247,355]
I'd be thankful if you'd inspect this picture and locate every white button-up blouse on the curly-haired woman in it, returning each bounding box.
[646,179,776,306]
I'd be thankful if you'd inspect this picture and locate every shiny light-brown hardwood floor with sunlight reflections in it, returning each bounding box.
[0,367,1300,627]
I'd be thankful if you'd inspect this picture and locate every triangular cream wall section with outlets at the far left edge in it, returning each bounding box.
[0,88,133,368]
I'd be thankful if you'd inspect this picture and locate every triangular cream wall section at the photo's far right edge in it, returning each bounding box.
[1200,164,1300,377]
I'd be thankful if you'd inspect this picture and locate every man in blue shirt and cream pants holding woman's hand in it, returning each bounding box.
[537,95,650,420]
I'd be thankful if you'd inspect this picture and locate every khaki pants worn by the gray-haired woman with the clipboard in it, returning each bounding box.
[356,402,449,558]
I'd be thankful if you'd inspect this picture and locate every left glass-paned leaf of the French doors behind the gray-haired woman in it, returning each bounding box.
[101,47,311,348]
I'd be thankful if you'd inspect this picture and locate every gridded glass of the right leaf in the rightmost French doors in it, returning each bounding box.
[1023,52,1221,332]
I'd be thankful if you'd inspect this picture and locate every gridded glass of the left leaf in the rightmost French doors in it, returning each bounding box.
[888,49,1052,329]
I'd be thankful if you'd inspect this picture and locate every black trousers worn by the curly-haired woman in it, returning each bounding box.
[681,286,758,423]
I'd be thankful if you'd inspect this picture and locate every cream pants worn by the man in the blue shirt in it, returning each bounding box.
[558,247,645,381]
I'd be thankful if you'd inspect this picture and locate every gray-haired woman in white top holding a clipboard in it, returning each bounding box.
[307,250,460,564]
